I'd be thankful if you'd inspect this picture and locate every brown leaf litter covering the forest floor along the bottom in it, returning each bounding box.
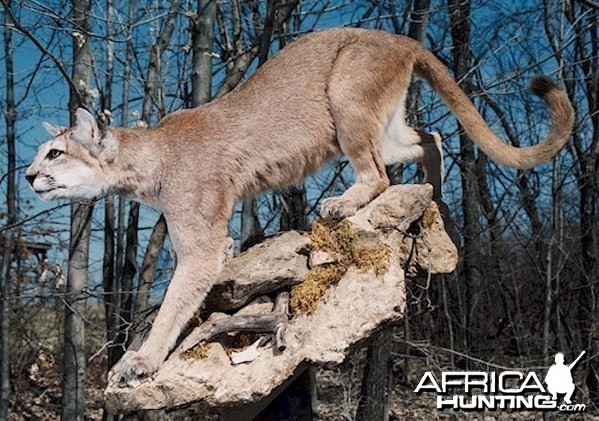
[8,342,599,421]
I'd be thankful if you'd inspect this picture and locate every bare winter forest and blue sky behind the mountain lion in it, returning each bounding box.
[0,0,599,419]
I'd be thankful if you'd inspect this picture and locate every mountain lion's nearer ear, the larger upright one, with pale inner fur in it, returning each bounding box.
[72,108,116,158]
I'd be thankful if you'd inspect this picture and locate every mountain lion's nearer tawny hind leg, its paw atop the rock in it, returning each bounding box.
[321,43,412,218]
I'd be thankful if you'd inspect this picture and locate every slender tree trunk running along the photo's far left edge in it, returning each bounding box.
[0,2,17,420]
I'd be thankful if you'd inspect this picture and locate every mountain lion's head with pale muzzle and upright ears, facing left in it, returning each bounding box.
[25,108,117,200]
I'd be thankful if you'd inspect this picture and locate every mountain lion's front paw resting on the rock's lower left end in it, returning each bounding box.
[108,351,162,387]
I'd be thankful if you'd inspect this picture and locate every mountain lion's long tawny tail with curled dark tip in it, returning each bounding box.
[414,42,574,169]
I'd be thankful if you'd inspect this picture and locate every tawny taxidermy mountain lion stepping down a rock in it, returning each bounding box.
[26,29,574,382]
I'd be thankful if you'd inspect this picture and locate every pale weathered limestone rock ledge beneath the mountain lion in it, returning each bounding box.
[105,186,457,417]
